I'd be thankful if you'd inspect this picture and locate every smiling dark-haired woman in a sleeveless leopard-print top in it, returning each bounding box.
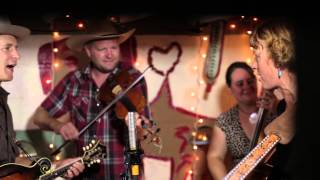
[207,62,276,179]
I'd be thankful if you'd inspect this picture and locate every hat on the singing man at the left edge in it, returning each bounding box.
[0,17,31,40]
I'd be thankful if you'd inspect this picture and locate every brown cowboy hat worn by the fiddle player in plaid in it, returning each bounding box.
[66,22,135,52]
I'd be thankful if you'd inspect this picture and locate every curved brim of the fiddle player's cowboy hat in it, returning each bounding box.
[66,29,135,52]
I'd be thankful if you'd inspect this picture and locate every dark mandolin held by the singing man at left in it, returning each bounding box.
[0,140,106,180]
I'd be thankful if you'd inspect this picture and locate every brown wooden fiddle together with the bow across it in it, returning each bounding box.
[51,66,160,156]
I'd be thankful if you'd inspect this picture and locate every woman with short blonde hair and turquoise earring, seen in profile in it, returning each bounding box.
[250,19,297,179]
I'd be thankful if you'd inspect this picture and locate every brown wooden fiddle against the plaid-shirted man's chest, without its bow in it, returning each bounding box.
[97,68,160,144]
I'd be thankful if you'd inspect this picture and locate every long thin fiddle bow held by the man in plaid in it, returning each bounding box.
[51,66,151,156]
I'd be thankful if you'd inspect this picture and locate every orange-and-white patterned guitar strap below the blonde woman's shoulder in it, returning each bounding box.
[223,134,280,180]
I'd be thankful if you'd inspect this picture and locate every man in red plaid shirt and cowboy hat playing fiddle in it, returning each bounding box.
[32,18,149,179]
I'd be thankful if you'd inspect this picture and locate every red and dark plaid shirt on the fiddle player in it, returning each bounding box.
[41,63,149,179]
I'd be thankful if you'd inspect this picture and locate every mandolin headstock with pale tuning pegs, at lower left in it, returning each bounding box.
[82,140,106,167]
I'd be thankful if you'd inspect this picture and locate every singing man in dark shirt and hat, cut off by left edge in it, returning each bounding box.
[0,17,84,179]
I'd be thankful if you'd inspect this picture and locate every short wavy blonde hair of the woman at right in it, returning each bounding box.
[250,20,295,70]
